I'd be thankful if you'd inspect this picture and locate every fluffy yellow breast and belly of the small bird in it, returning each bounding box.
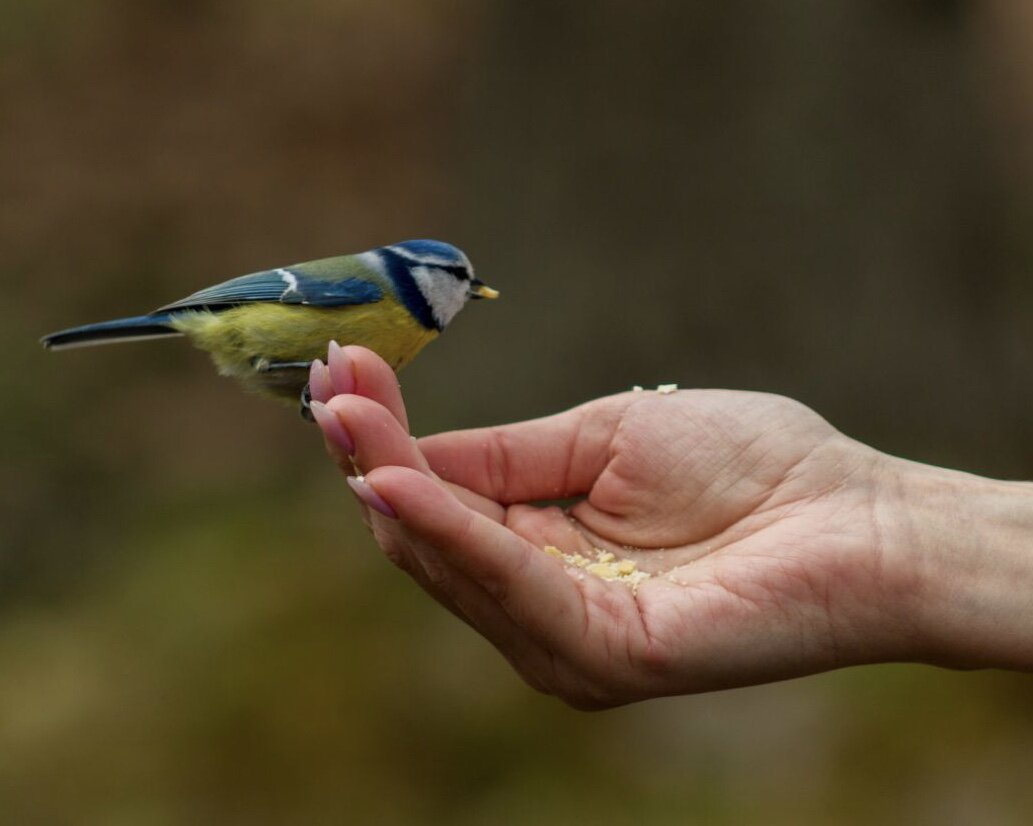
[171,295,438,401]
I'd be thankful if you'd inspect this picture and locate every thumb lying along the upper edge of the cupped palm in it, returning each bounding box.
[418,393,635,504]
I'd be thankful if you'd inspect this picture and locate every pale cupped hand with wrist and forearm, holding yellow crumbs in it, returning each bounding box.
[311,346,1033,709]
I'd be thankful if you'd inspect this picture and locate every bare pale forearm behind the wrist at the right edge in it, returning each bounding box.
[890,460,1033,671]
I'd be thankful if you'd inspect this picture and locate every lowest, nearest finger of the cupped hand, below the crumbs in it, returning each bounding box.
[366,467,586,654]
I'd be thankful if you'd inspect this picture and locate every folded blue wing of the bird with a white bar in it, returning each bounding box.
[155,264,383,313]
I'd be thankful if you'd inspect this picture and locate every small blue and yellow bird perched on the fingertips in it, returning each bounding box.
[41,241,499,419]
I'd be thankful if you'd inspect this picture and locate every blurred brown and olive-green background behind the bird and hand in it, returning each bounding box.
[0,0,1033,826]
